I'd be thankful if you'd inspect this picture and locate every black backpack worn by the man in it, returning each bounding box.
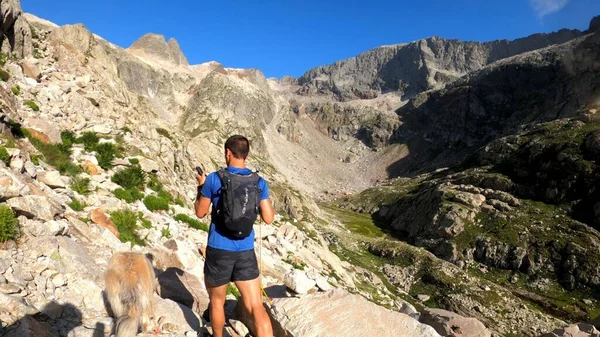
[212,169,260,239]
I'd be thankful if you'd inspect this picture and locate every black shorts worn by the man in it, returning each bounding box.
[204,247,259,287]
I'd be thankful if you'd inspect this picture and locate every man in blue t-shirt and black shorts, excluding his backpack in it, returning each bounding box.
[194,135,274,337]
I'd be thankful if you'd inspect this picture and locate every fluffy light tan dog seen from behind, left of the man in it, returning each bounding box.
[105,252,159,337]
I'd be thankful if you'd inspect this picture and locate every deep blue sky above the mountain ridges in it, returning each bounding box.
[21,0,600,77]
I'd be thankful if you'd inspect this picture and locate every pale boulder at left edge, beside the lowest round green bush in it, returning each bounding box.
[6,195,65,221]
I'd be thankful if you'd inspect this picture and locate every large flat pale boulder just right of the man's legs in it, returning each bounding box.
[238,289,439,337]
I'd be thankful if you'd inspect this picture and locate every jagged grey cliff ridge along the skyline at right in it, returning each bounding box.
[298,30,582,101]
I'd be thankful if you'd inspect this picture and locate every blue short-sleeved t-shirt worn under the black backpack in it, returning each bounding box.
[200,166,269,252]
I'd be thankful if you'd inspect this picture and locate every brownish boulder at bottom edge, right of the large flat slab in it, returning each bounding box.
[419,309,492,337]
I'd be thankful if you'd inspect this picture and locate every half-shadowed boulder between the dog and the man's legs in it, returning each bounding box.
[158,268,208,312]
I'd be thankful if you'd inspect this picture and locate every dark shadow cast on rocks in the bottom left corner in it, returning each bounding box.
[0,301,91,337]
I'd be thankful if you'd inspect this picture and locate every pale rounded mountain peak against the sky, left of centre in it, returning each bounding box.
[128,33,188,65]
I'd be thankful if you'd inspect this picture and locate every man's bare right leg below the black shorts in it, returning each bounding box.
[234,277,273,337]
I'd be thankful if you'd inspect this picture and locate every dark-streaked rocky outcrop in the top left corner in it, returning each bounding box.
[0,0,33,58]
